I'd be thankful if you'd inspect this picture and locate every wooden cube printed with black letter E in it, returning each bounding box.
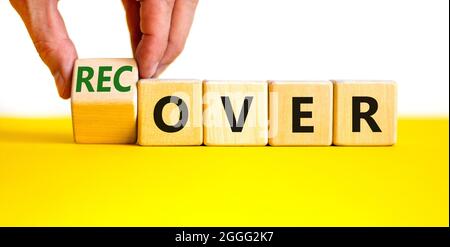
[269,81,333,146]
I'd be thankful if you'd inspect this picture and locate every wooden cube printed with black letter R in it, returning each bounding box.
[333,81,397,146]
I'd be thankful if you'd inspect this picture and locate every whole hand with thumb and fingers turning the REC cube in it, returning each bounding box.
[10,0,198,99]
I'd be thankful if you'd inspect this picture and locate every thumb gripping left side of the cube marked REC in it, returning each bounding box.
[10,0,78,99]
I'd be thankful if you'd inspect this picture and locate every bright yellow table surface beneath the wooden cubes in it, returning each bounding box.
[0,117,449,226]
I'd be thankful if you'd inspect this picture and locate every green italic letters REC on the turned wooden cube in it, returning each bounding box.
[76,65,133,93]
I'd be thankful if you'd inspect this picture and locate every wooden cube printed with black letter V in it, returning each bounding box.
[203,81,268,146]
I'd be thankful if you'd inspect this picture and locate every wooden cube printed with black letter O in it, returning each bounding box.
[138,79,203,146]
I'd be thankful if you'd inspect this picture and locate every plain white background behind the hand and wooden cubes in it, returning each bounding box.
[0,0,449,116]
